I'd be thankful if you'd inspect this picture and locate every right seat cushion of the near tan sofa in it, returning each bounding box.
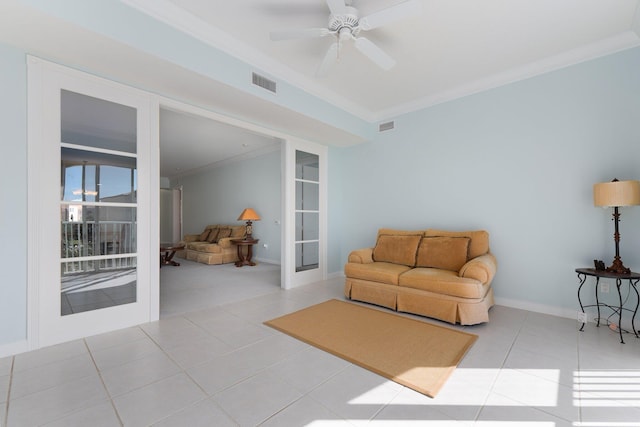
[398,267,487,298]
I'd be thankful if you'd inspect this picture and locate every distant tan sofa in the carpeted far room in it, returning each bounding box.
[176,225,247,264]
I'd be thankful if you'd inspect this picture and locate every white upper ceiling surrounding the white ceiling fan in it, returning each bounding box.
[125,0,640,121]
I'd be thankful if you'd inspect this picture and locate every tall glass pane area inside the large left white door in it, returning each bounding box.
[60,90,137,316]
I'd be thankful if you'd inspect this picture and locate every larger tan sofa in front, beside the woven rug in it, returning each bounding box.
[344,228,497,325]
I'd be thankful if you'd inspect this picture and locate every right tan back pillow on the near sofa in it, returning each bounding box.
[416,236,470,272]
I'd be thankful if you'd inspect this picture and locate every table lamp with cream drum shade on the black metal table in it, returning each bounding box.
[593,179,640,274]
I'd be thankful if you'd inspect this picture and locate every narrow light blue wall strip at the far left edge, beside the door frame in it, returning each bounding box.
[0,44,27,346]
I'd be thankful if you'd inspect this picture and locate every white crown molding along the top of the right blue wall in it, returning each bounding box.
[375,31,640,122]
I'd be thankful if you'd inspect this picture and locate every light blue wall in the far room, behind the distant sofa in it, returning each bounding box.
[172,150,282,264]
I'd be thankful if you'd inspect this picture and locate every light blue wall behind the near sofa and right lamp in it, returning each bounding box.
[329,48,640,311]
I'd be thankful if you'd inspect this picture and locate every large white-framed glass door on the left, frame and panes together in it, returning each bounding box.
[29,60,158,347]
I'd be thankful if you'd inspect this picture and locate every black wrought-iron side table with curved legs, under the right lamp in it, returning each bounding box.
[576,268,640,344]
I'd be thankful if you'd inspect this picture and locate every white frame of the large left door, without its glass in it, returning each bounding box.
[27,56,160,349]
